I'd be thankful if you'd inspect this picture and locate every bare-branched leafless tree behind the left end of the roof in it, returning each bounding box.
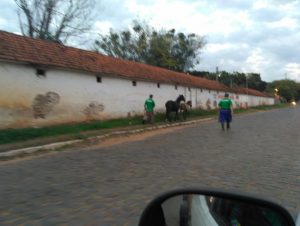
[15,0,95,43]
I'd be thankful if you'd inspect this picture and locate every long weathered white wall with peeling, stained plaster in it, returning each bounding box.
[0,62,274,128]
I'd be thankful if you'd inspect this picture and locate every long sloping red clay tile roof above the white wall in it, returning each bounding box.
[0,31,266,96]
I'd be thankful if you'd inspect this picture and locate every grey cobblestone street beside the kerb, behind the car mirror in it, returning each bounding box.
[0,108,300,226]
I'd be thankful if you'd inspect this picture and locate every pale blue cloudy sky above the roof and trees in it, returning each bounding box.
[0,0,300,81]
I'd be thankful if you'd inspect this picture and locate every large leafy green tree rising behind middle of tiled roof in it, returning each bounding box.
[95,21,205,71]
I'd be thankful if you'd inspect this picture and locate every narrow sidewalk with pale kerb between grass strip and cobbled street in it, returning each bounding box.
[0,117,213,160]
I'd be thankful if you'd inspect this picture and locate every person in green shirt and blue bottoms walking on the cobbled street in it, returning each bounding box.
[219,93,233,131]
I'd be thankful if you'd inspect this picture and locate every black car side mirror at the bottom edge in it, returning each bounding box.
[139,189,295,226]
